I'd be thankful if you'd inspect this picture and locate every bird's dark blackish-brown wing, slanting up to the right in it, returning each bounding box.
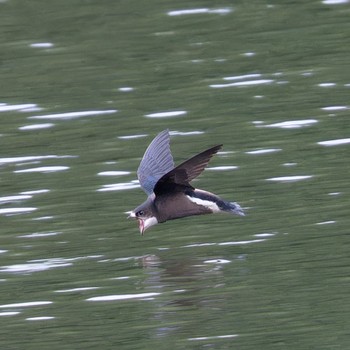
[154,145,222,195]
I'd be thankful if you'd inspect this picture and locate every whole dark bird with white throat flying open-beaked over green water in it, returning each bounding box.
[129,130,244,235]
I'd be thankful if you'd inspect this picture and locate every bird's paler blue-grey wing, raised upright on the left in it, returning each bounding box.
[137,129,174,195]
